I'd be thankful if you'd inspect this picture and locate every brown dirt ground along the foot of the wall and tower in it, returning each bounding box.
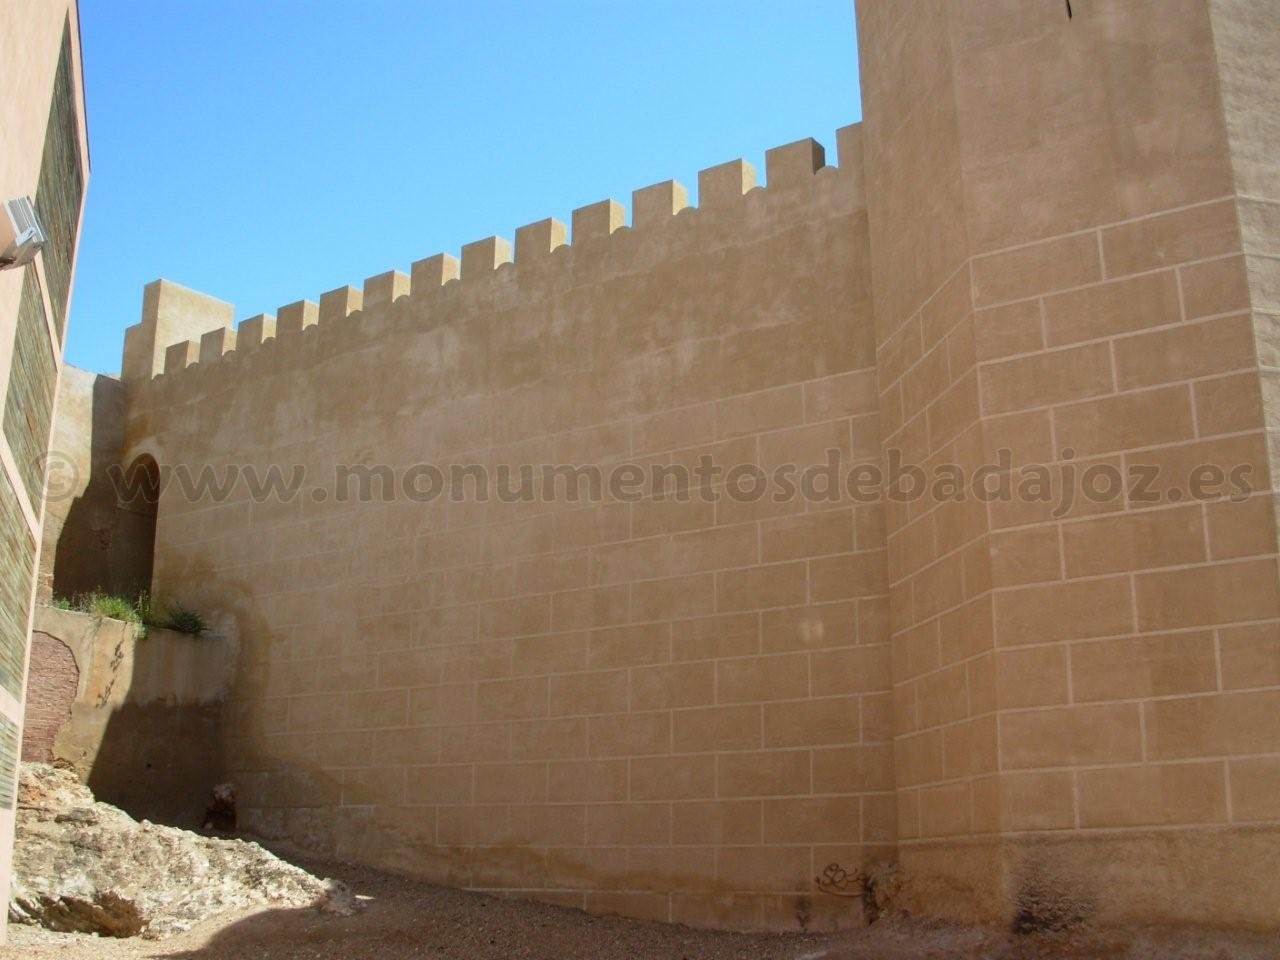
[0,864,1280,960]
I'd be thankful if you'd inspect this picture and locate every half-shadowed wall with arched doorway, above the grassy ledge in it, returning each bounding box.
[41,367,157,599]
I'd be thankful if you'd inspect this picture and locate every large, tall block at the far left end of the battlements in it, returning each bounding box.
[120,280,236,381]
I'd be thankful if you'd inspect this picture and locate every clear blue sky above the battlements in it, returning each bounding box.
[67,0,859,372]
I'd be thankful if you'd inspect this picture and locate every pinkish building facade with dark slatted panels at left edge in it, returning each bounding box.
[0,0,88,923]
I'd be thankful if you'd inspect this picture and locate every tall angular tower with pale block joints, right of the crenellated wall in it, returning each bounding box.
[858,0,1280,925]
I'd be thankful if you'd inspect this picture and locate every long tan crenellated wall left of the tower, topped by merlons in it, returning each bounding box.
[117,127,895,927]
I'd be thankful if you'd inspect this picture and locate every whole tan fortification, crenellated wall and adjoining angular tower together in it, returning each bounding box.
[80,0,1280,927]
